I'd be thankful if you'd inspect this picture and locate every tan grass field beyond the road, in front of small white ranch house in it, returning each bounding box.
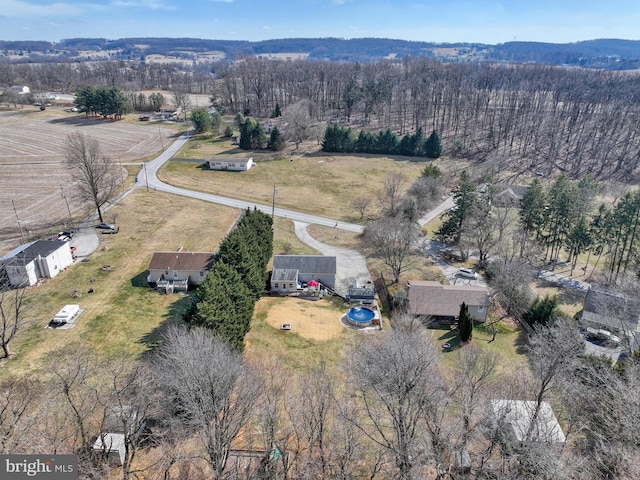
[158,147,424,222]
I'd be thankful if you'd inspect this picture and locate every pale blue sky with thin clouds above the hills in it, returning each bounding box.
[0,0,640,44]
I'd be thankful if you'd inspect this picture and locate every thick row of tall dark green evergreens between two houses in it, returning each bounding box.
[184,209,273,351]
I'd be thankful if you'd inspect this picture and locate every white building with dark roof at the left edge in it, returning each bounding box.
[0,240,73,287]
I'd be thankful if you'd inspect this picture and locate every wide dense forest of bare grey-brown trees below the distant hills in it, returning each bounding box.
[0,57,640,182]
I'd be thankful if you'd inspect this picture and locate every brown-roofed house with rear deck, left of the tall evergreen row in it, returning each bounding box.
[147,252,214,293]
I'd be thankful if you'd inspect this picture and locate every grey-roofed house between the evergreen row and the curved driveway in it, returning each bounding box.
[271,255,336,294]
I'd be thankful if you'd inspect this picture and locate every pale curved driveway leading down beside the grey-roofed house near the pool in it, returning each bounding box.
[293,221,371,296]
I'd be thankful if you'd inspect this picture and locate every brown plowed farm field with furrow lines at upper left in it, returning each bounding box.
[0,106,175,254]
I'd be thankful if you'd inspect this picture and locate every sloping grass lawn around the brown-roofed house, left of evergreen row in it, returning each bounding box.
[0,189,239,375]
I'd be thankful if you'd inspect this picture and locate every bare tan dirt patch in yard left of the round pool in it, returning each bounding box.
[256,297,346,340]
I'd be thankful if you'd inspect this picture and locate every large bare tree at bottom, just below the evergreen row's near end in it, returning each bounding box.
[154,328,262,479]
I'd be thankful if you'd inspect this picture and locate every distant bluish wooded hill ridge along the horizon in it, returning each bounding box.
[0,38,640,70]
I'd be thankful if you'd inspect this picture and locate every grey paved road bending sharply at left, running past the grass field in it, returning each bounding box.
[136,132,364,233]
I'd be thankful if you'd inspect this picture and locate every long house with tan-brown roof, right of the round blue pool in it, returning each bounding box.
[409,280,489,326]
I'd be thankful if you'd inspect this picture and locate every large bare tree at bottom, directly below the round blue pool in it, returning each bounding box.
[347,329,441,479]
